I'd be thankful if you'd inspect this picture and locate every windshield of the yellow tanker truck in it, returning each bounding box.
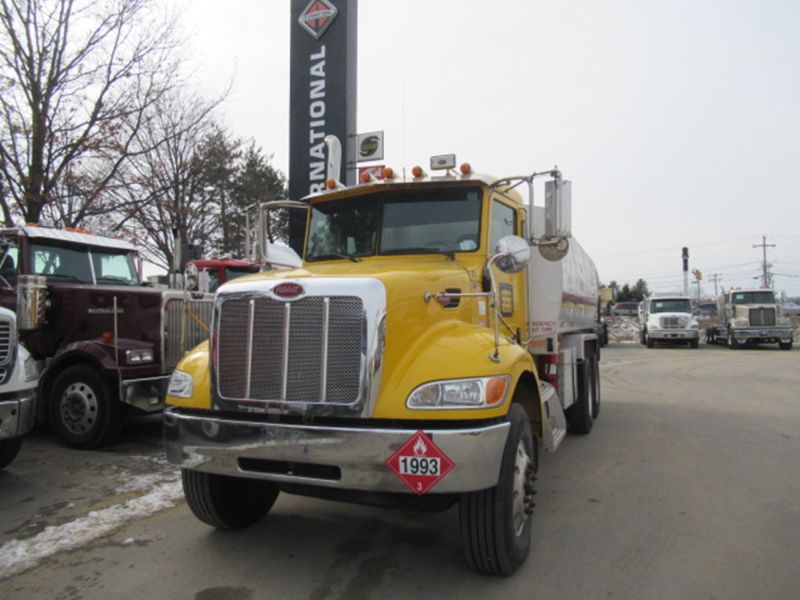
[305,187,482,261]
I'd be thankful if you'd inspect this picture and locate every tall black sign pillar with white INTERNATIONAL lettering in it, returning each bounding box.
[289,0,358,250]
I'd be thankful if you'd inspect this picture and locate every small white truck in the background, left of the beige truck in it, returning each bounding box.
[639,296,700,348]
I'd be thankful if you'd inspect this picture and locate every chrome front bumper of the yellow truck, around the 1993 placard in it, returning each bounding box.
[164,408,510,494]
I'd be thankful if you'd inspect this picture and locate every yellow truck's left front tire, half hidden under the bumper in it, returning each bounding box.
[181,469,280,529]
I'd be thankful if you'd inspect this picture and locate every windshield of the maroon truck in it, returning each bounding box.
[30,243,139,285]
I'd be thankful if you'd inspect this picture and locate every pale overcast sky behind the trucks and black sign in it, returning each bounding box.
[175,0,800,296]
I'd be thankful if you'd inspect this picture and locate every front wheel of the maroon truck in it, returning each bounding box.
[48,365,122,450]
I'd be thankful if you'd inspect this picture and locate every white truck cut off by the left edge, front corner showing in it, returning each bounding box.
[0,307,41,469]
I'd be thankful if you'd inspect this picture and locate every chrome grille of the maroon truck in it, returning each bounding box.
[163,292,213,371]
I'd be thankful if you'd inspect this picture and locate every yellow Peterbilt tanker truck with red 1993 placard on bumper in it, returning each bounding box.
[164,155,600,574]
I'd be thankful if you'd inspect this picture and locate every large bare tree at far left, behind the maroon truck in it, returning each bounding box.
[0,0,177,226]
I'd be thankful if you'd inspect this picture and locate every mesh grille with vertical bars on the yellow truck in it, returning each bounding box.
[217,296,366,404]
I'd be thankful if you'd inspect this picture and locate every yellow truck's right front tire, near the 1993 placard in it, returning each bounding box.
[459,402,539,575]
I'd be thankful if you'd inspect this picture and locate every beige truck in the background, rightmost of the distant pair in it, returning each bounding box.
[706,288,794,350]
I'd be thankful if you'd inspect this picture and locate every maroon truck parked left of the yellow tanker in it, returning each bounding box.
[0,226,212,448]
